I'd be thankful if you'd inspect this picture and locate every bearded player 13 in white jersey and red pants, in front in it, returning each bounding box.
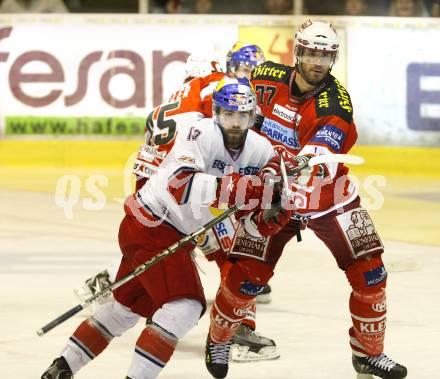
[42,77,291,379]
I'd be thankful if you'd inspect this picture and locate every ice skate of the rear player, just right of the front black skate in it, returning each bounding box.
[231,325,280,362]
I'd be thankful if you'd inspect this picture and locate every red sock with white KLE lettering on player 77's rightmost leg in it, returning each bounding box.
[346,255,387,356]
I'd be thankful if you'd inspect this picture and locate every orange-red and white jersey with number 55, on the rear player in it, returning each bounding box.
[133,72,225,185]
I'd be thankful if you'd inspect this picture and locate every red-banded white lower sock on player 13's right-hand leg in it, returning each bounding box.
[127,323,177,379]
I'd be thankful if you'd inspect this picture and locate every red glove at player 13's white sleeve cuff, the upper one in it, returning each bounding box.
[212,173,263,210]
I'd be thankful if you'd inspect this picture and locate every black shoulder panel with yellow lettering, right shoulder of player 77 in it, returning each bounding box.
[315,75,353,124]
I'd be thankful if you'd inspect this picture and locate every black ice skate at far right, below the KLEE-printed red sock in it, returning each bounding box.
[352,353,407,379]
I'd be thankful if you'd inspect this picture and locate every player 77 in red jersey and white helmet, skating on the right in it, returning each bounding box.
[206,20,407,379]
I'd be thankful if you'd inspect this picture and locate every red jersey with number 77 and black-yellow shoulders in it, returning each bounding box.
[251,61,357,218]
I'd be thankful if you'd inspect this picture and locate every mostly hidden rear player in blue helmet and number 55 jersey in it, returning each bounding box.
[75,42,280,362]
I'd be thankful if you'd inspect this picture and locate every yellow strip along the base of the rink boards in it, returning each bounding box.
[0,137,440,177]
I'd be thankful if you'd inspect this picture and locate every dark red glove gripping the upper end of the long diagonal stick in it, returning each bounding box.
[252,204,293,237]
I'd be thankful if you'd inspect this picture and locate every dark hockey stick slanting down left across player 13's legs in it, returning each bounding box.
[37,206,239,336]
